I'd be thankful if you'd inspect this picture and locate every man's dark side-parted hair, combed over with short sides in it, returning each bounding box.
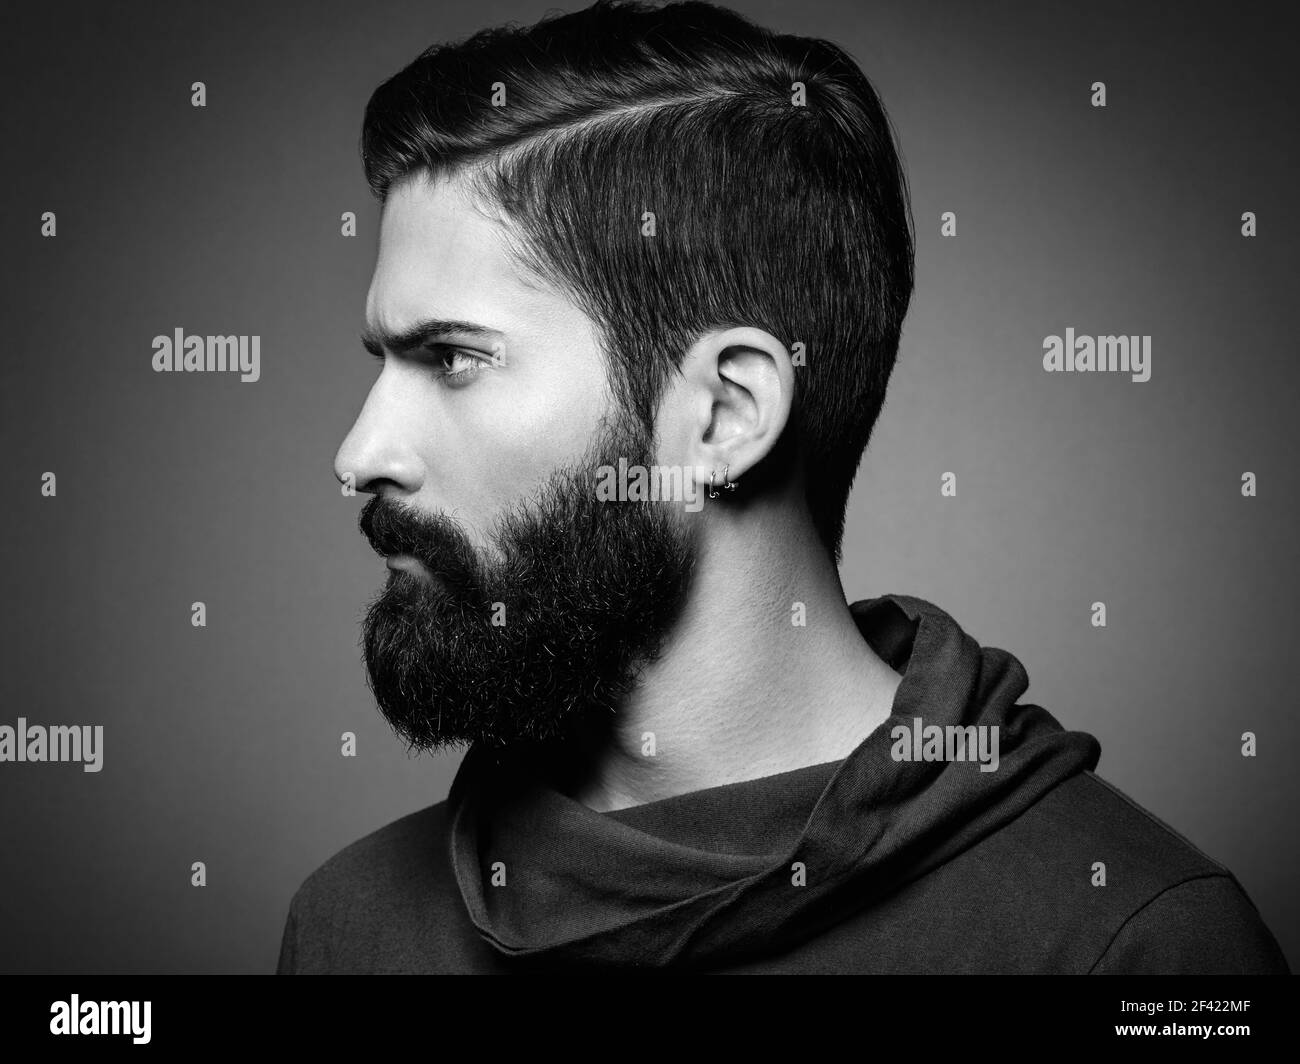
[361,0,914,559]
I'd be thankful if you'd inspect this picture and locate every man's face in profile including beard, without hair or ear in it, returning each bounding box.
[335,177,694,748]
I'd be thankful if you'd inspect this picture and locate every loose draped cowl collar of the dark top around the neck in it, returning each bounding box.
[447,594,1101,969]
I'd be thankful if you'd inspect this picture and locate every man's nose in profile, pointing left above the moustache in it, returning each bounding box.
[334,367,424,494]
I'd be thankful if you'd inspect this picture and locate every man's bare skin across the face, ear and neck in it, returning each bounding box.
[335,170,901,810]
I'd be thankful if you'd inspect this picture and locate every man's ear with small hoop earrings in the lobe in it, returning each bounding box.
[660,326,794,484]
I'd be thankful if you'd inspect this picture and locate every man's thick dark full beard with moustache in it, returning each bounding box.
[360,418,696,751]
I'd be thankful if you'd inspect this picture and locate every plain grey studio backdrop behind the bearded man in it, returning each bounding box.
[0,0,1300,972]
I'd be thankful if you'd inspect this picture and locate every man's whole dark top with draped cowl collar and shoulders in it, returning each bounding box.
[277,594,1288,973]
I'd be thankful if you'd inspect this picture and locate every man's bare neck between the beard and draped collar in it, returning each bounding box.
[543,504,902,812]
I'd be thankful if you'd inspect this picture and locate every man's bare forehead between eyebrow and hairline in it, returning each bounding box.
[365,176,551,332]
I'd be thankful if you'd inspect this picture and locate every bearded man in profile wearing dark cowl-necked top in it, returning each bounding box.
[269,1,1286,973]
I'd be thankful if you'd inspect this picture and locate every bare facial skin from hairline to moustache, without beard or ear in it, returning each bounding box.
[335,170,612,545]
